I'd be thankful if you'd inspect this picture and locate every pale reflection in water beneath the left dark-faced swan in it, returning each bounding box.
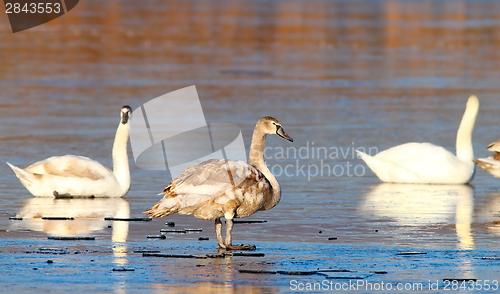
[14,197,130,242]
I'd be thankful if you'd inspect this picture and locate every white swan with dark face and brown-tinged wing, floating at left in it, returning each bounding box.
[7,106,132,197]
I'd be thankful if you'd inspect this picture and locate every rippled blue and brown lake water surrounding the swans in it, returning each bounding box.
[0,1,500,293]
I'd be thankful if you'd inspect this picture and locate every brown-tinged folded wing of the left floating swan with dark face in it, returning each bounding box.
[26,155,112,180]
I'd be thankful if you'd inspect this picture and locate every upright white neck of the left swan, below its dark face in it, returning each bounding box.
[113,122,130,192]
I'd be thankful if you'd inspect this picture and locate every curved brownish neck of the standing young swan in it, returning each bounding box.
[248,126,281,210]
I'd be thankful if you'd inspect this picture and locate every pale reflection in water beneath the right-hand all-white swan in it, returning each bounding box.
[360,183,475,249]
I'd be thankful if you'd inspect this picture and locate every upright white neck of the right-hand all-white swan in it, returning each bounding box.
[456,96,479,162]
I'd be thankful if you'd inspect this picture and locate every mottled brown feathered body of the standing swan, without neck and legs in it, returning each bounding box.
[146,159,272,219]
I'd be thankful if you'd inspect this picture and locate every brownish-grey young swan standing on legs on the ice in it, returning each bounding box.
[144,116,293,250]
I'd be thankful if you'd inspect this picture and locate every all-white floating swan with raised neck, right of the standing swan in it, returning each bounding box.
[357,96,479,184]
